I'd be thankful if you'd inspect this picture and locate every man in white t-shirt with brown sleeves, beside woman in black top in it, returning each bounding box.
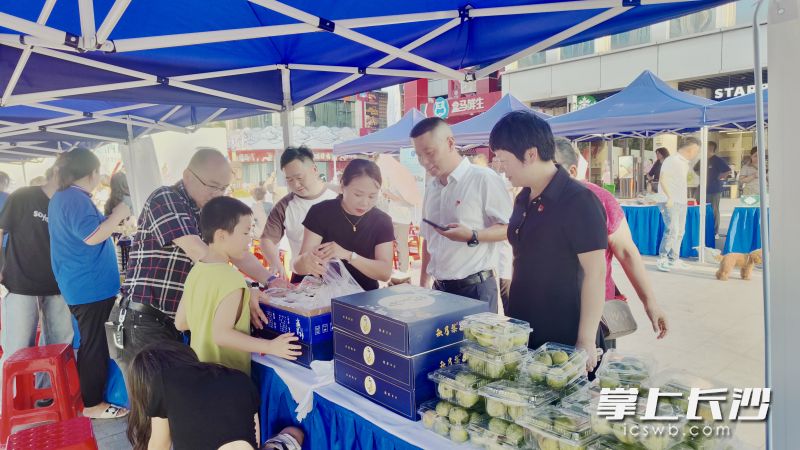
[261,146,338,283]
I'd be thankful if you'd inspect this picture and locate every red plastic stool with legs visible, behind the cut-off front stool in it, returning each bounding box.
[0,344,83,442]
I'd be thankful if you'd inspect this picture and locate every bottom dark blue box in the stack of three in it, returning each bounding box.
[333,358,454,421]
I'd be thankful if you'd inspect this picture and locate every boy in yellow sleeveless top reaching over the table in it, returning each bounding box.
[175,197,300,374]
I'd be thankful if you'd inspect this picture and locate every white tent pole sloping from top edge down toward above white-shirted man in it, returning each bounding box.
[249,0,465,80]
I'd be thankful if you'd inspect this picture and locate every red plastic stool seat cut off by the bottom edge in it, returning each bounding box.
[6,417,97,450]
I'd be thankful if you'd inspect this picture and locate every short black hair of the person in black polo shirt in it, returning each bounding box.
[489,111,556,161]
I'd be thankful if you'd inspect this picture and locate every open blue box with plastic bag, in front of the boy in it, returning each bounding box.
[253,304,333,367]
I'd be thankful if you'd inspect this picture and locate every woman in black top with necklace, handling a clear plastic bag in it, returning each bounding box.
[294,159,394,291]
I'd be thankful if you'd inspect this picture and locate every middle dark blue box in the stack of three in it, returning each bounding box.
[333,330,462,391]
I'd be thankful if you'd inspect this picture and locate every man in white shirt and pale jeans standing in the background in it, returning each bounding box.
[657,137,700,272]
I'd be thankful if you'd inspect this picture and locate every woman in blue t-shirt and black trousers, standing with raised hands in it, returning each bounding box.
[48,148,131,419]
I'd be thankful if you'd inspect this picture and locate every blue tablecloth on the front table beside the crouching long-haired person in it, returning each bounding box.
[252,362,422,450]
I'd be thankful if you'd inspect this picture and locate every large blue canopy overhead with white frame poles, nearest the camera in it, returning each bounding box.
[0,0,729,162]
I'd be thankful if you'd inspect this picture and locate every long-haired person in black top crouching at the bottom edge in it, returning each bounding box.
[128,341,303,450]
